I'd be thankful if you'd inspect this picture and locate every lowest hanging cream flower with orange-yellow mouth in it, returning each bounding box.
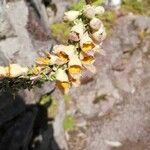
[56,68,70,93]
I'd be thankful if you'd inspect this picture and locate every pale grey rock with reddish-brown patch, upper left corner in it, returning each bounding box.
[0,0,52,66]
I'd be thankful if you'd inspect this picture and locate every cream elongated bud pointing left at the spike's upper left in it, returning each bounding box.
[64,10,80,21]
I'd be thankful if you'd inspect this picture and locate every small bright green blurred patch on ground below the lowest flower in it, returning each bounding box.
[63,115,75,131]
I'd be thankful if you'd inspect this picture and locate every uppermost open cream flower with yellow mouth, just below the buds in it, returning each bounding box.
[80,32,95,52]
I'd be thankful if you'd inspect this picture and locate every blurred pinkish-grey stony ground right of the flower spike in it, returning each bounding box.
[70,16,150,150]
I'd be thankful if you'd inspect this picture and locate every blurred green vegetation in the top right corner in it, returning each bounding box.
[122,0,150,16]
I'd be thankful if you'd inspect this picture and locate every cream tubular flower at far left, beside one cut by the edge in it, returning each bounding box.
[6,64,28,78]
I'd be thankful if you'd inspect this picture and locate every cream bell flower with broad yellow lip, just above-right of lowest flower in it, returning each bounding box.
[68,55,82,74]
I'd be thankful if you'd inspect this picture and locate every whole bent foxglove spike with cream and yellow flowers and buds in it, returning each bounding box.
[0,5,106,93]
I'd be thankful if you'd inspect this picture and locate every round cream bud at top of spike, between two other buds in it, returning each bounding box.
[83,5,96,19]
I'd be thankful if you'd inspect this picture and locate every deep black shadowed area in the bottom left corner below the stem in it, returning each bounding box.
[0,93,60,150]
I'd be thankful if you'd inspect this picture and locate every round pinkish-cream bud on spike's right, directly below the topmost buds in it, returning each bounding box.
[90,17,103,30]
